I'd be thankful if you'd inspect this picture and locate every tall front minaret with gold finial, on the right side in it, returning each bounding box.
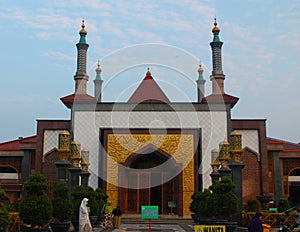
[210,18,225,94]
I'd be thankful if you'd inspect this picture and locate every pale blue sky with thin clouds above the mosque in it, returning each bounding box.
[0,0,300,143]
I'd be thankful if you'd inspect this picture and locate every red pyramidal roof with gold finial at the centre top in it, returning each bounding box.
[128,69,170,103]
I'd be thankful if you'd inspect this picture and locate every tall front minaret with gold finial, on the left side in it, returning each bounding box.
[74,20,89,94]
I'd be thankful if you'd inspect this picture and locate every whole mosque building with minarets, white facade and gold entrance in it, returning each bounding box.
[0,20,300,216]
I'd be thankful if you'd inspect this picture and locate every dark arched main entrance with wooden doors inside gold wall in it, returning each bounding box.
[124,149,179,214]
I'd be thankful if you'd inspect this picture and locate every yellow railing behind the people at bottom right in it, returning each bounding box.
[243,211,297,228]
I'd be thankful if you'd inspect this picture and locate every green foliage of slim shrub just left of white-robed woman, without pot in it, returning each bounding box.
[52,183,73,222]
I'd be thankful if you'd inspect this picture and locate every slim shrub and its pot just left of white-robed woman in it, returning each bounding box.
[50,183,73,232]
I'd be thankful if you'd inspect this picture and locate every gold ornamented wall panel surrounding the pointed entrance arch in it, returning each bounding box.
[106,134,195,215]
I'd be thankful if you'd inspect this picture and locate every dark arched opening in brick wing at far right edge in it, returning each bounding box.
[288,168,300,204]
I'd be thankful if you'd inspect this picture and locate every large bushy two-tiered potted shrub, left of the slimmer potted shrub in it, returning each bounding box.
[20,173,52,231]
